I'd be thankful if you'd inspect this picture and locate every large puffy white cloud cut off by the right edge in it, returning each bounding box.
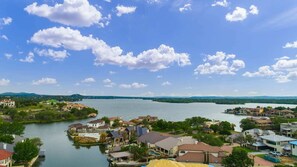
[243,57,297,83]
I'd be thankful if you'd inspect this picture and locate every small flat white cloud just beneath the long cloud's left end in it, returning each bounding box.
[34,49,69,61]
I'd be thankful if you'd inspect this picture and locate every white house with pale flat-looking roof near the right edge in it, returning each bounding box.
[260,135,297,152]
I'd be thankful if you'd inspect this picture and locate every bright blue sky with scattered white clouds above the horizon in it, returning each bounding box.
[0,0,297,96]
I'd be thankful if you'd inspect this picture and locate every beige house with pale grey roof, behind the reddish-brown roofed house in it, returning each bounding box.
[155,136,197,156]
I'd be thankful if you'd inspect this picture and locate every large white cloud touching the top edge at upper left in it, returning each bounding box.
[25,0,102,27]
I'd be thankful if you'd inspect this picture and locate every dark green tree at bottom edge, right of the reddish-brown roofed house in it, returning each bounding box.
[222,147,254,167]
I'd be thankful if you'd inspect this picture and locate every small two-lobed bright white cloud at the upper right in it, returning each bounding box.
[225,5,259,22]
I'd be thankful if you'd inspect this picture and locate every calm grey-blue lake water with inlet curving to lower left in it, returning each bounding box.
[25,100,295,167]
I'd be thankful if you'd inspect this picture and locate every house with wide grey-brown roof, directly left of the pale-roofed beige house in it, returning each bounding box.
[137,132,168,148]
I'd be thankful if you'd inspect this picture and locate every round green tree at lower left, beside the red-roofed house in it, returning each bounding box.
[12,139,39,164]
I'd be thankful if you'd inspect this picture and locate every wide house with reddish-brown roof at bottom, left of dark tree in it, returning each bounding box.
[176,142,226,164]
